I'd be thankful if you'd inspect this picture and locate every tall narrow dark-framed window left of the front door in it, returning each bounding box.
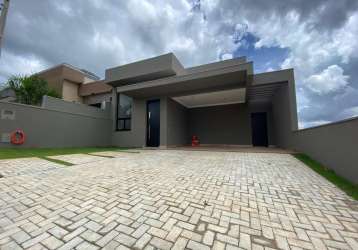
[117,94,133,130]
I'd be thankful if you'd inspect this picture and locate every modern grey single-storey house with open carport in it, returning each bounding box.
[104,53,297,148]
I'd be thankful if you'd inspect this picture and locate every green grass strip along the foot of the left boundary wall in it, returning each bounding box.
[0,147,128,159]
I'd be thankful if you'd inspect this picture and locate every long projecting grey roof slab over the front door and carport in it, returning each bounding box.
[106,63,252,98]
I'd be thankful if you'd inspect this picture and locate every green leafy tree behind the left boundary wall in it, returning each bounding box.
[6,75,61,105]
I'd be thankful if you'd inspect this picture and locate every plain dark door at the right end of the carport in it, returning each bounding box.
[251,112,268,147]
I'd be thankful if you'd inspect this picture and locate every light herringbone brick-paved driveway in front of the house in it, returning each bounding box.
[0,150,358,249]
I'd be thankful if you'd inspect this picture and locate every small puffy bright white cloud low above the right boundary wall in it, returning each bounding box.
[305,65,349,95]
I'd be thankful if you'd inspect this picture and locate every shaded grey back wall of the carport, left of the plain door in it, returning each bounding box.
[189,104,252,145]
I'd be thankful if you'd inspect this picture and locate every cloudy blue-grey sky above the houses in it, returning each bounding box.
[0,0,358,127]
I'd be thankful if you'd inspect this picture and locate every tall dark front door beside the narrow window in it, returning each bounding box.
[147,100,160,147]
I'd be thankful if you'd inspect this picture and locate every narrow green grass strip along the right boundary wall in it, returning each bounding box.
[294,154,358,200]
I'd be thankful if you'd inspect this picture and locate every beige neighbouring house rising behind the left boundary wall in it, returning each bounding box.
[36,64,112,107]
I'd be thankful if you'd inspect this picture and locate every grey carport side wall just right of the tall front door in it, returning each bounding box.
[167,98,190,146]
